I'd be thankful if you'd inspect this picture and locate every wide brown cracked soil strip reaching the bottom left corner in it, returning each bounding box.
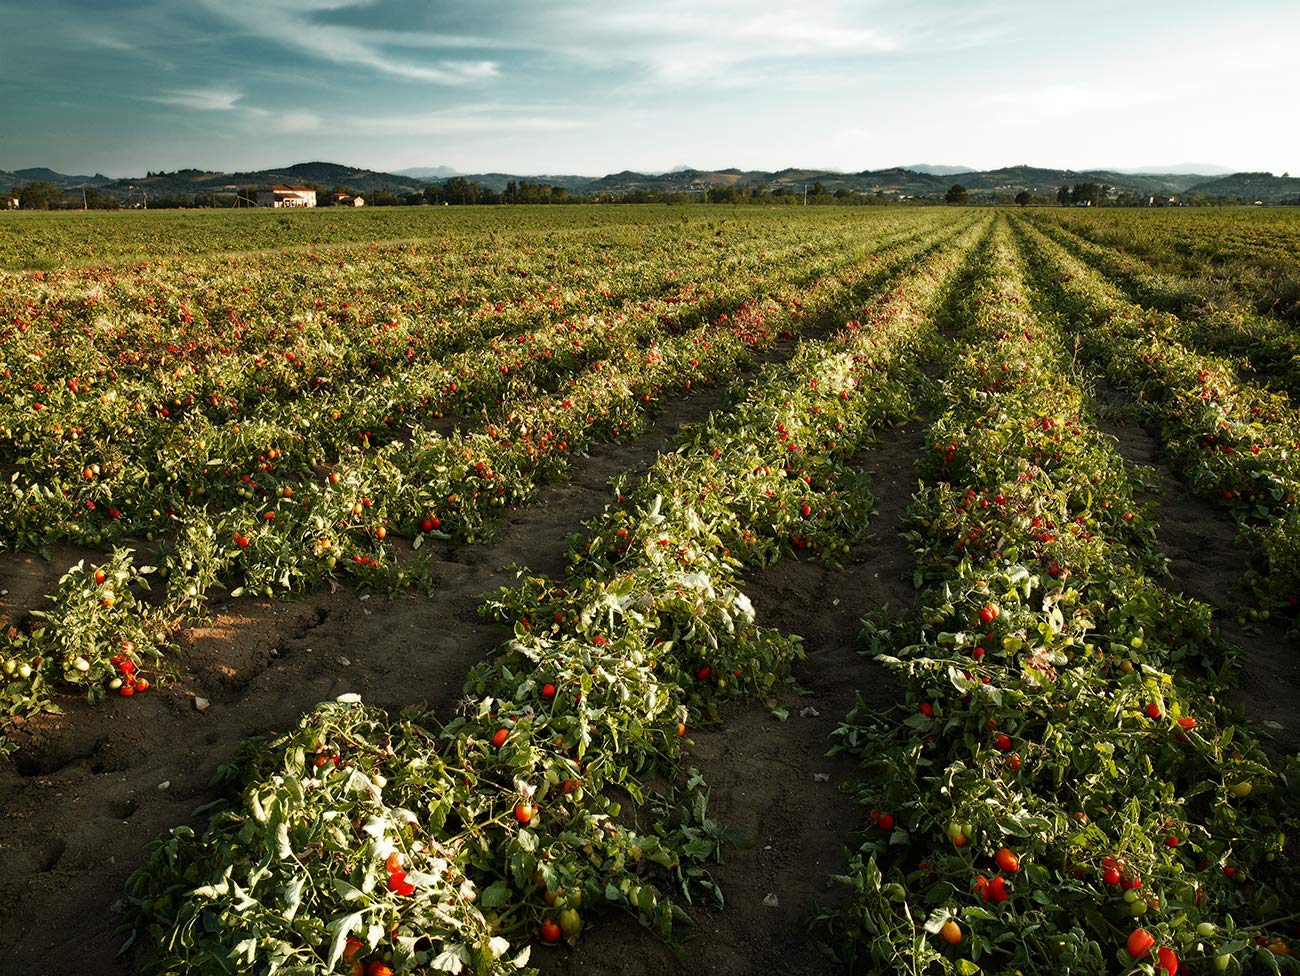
[0,376,738,976]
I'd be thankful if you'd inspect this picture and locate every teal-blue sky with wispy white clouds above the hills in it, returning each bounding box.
[0,0,1300,177]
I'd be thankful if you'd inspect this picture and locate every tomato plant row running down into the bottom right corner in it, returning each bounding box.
[815,220,1300,976]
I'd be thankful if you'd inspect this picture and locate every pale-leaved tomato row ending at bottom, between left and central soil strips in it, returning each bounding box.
[127,217,975,976]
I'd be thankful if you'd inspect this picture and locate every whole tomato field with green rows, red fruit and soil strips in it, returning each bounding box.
[0,205,1300,976]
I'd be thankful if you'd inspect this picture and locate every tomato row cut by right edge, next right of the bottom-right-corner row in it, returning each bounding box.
[1019,217,1300,636]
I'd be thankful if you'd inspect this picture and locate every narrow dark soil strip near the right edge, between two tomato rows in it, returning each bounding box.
[1101,389,1300,755]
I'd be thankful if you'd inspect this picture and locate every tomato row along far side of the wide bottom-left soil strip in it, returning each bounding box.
[0,217,967,738]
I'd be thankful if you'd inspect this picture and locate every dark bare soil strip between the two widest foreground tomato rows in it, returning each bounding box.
[534,424,922,976]
